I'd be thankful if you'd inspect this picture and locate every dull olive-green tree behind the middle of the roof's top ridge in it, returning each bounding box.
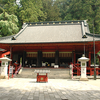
[42,0,61,21]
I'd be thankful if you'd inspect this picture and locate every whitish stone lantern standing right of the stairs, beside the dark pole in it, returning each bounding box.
[78,54,89,81]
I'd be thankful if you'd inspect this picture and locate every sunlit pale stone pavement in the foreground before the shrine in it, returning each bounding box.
[0,78,100,100]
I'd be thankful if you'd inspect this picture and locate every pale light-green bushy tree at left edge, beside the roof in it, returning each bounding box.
[0,12,19,37]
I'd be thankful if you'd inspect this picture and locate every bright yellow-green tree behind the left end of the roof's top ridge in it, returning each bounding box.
[19,0,46,22]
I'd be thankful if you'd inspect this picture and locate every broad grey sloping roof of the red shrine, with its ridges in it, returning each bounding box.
[0,20,100,43]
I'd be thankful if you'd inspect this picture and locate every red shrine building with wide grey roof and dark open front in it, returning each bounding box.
[0,20,100,68]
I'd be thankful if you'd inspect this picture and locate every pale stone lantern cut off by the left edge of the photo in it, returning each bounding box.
[0,55,12,79]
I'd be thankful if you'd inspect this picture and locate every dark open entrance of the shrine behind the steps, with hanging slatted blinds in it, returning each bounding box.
[23,51,73,68]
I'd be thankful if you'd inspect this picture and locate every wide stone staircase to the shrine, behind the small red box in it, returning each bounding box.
[15,68,70,79]
